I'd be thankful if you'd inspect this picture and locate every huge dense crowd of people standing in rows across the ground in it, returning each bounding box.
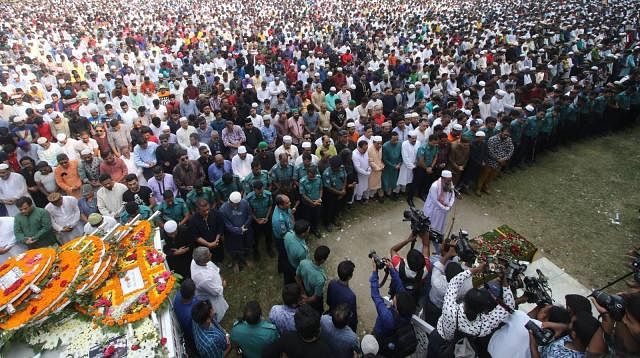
[0,0,640,357]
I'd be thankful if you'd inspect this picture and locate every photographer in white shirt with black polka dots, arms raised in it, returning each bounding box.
[427,263,515,357]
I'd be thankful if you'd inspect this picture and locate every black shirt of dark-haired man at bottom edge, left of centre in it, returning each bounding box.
[262,332,333,358]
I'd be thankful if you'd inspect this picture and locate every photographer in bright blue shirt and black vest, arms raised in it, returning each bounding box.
[369,256,417,357]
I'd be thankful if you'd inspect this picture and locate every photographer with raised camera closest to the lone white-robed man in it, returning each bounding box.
[389,233,431,303]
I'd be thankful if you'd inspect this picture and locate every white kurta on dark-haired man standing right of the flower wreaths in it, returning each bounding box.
[191,260,229,322]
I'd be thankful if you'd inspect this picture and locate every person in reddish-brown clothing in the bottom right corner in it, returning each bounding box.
[587,292,640,357]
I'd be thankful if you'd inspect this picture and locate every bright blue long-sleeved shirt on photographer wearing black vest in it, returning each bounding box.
[369,270,410,337]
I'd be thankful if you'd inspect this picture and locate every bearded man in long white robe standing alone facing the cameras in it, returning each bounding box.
[422,170,456,242]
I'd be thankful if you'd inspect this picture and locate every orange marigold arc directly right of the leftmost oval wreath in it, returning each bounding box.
[0,251,81,330]
